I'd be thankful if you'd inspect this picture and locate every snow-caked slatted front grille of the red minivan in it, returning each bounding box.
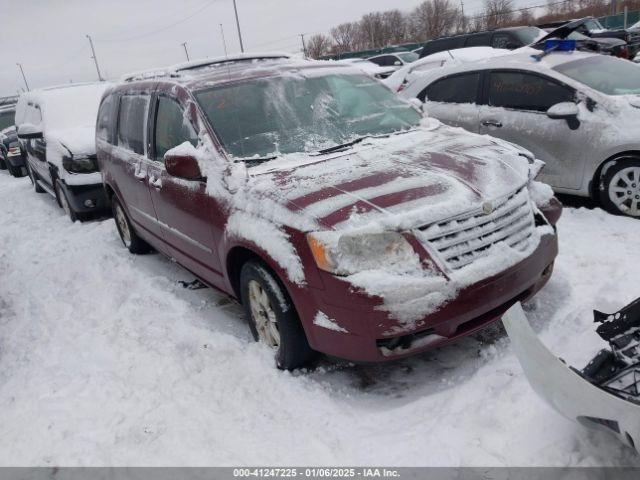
[420,187,535,270]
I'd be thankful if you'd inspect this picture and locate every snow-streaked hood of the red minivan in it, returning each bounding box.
[249,121,529,230]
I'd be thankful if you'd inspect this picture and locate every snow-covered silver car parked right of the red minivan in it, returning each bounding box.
[401,45,640,217]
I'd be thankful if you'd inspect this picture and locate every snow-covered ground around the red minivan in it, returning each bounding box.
[0,172,640,466]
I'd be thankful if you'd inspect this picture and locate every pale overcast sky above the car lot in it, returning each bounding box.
[0,0,496,96]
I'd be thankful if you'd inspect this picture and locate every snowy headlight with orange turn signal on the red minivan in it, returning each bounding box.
[307,232,420,275]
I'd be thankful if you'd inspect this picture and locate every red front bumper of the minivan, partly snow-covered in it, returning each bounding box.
[294,231,558,362]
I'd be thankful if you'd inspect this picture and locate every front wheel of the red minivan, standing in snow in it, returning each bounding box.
[240,260,316,370]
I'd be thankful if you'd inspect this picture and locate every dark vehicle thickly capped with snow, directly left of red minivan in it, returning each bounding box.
[16,82,108,221]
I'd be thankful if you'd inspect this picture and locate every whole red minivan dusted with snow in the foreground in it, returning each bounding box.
[96,55,561,369]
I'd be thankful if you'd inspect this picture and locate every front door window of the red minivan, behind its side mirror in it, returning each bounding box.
[154,96,198,162]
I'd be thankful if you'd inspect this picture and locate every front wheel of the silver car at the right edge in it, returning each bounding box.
[600,158,640,218]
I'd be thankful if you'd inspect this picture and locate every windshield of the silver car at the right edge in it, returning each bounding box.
[554,55,640,95]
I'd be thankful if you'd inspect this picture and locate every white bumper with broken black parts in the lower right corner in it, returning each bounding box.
[503,299,640,450]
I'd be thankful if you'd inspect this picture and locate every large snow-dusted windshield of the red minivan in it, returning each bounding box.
[195,74,421,159]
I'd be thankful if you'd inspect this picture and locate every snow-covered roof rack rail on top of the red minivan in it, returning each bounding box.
[120,52,295,82]
